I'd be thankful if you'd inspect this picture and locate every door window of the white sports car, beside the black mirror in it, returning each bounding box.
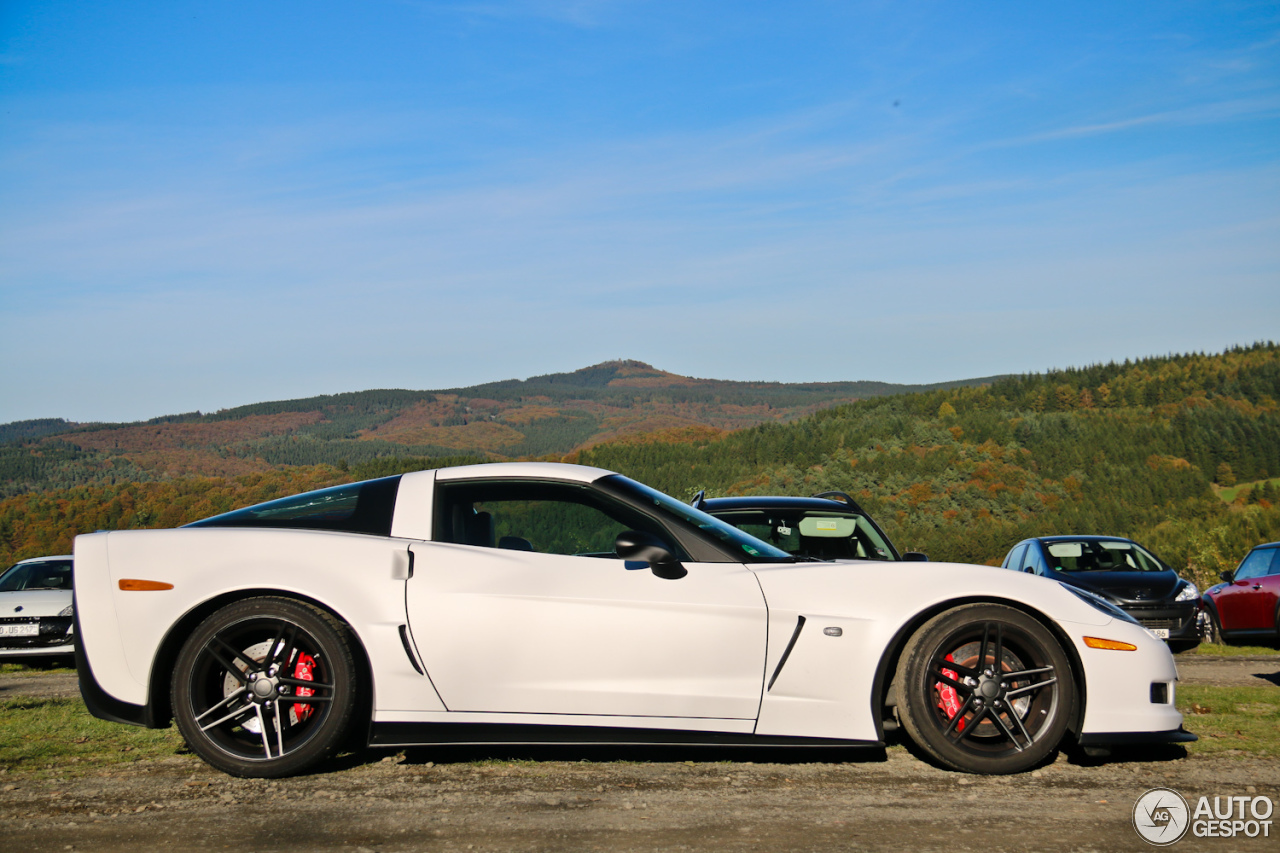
[434,480,684,558]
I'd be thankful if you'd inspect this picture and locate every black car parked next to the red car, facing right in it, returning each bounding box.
[1001,535,1201,649]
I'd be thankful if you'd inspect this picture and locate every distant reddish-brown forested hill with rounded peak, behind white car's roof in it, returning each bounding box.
[0,361,996,497]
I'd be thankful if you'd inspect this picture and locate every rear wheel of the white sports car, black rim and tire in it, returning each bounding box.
[172,597,357,779]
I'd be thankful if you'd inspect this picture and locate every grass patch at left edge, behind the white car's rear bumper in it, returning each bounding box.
[0,698,186,772]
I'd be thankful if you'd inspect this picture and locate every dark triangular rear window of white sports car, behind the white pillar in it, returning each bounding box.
[186,475,401,537]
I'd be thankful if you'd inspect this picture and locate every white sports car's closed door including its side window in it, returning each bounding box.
[407,483,768,720]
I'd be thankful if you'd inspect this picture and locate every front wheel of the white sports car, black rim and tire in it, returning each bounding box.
[896,605,1075,775]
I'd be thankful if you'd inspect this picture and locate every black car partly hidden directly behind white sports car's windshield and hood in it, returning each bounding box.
[694,492,928,561]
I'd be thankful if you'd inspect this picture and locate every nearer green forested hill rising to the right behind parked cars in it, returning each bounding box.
[575,343,1280,585]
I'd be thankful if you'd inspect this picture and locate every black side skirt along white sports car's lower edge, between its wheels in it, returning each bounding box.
[369,722,884,749]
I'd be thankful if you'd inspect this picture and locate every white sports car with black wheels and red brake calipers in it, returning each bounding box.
[76,462,1194,776]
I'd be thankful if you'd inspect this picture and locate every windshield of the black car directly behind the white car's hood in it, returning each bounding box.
[716,507,899,561]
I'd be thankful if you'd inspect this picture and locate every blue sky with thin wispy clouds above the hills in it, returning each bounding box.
[0,0,1280,423]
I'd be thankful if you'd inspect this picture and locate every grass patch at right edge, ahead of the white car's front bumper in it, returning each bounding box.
[1178,684,1280,758]
